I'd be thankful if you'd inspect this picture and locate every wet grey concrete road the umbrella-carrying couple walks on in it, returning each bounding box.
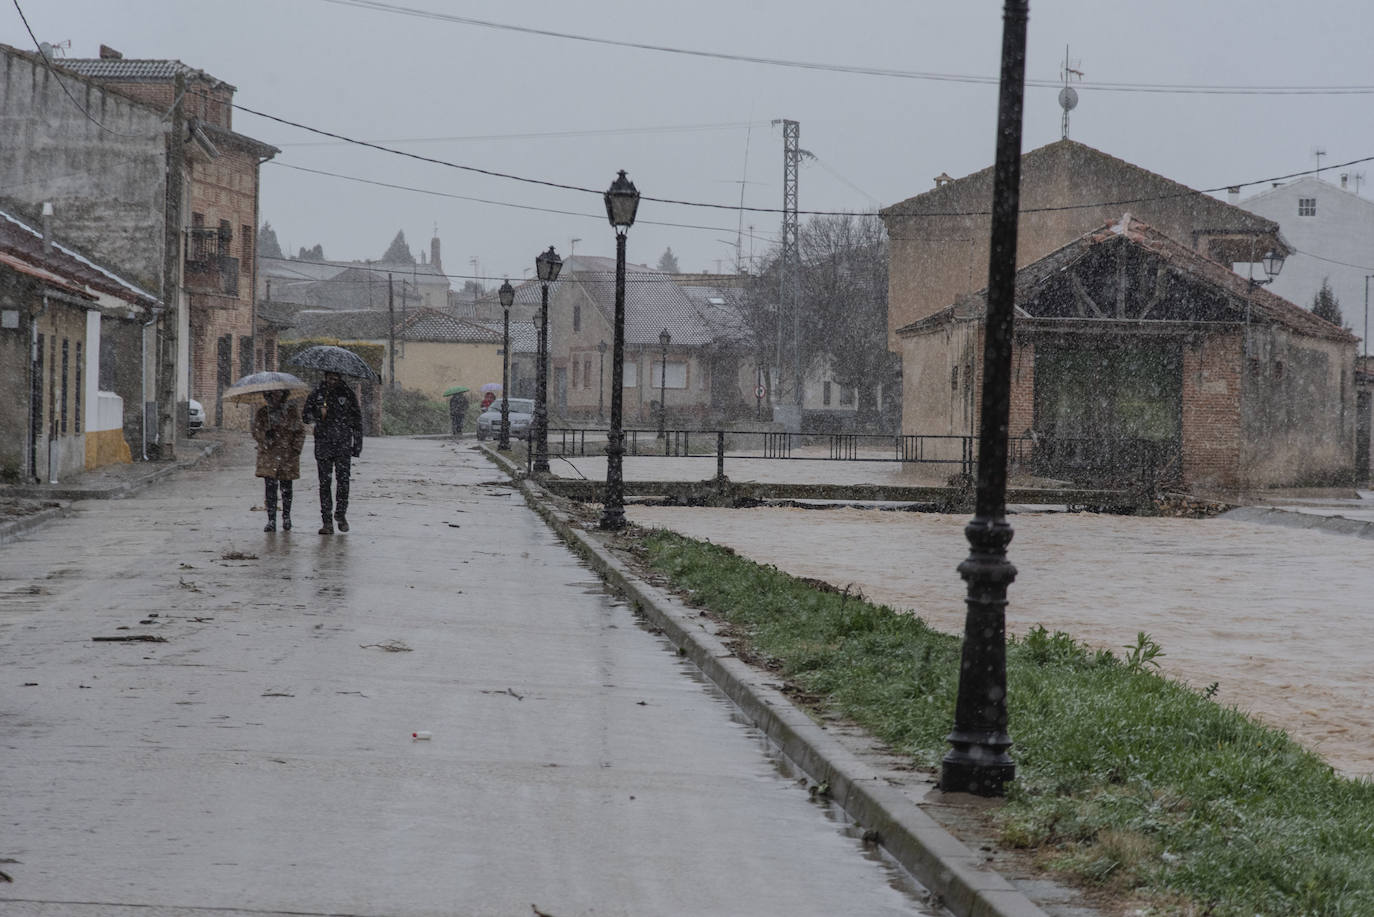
[0,440,941,917]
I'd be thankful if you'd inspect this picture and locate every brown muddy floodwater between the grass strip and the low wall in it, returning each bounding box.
[628,506,1374,775]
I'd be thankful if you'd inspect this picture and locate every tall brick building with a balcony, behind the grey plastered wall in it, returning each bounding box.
[60,45,279,429]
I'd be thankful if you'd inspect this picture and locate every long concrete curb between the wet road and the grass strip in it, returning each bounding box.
[484,450,1047,917]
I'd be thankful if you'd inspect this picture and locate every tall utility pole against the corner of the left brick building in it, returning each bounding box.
[156,73,190,459]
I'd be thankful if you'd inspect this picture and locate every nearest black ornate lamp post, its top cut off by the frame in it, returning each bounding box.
[940,0,1029,796]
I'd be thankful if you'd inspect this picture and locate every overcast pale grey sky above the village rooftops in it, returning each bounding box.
[10,0,1374,286]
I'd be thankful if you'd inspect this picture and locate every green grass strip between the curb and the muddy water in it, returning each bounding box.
[639,531,1374,917]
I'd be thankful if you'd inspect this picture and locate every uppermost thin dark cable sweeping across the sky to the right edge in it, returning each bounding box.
[323,0,1374,95]
